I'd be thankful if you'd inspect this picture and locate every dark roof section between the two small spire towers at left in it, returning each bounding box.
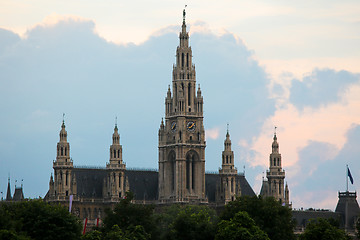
[72,168,106,198]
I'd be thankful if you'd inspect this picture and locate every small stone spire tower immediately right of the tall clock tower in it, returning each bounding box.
[216,125,240,204]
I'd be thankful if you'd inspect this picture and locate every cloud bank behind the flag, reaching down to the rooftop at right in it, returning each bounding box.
[287,124,360,210]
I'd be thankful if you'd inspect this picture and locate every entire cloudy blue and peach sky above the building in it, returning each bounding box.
[0,0,360,210]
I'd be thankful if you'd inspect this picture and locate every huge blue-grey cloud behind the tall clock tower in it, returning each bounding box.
[0,19,275,197]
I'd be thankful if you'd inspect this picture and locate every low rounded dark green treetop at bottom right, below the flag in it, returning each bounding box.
[299,218,349,240]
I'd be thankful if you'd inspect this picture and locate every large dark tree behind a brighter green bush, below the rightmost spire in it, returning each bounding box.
[221,196,295,240]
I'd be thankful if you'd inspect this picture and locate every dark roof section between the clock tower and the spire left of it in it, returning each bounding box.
[125,170,158,201]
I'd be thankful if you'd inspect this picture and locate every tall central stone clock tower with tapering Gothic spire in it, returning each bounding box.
[159,9,207,203]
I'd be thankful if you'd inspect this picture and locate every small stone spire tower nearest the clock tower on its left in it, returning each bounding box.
[104,123,127,201]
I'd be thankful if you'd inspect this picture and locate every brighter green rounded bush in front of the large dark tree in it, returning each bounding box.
[215,212,269,240]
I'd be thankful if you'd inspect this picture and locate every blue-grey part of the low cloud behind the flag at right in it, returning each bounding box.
[291,124,360,205]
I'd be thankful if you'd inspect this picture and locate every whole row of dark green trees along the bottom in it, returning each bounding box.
[0,193,350,240]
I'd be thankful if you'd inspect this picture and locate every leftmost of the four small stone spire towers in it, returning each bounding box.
[49,114,74,200]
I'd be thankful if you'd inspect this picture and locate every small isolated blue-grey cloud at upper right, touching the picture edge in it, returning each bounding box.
[290,69,360,110]
